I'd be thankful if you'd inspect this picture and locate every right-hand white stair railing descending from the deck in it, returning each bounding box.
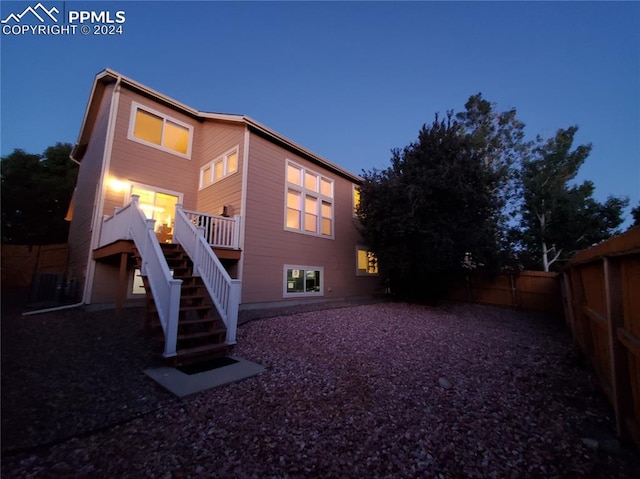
[173,204,242,345]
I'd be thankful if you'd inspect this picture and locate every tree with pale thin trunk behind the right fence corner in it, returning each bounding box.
[520,126,628,271]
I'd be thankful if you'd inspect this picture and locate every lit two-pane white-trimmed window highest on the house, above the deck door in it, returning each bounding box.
[129,102,193,159]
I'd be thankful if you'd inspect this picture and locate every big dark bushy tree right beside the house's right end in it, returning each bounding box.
[358,113,498,299]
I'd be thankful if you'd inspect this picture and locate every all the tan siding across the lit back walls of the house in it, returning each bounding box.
[72,79,378,305]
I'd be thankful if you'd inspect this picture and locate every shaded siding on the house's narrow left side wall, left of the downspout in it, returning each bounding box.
[67,82,113,297]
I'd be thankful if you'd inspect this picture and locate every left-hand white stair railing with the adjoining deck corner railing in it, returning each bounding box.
[98,195,182,358]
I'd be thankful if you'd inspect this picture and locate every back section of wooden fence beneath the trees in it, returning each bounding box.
[450,271,562,314]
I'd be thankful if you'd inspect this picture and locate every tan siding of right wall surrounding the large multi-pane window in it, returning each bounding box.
[242,135,378,306]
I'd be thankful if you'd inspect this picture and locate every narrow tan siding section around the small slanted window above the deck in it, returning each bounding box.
[196,121,244,216]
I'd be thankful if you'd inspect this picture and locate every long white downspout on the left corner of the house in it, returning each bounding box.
[82,76,122,304]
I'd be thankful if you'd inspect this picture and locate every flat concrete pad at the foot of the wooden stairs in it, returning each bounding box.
[144,356,266,398]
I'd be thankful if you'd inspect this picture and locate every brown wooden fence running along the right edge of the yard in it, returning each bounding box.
[562,226,640,446]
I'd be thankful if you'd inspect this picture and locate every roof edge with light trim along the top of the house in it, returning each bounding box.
[71,68,362,183]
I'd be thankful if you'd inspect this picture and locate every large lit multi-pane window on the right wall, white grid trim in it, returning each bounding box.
[284,161,333,238]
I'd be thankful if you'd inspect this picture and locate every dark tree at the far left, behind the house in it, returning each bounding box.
[0,143,78,244]
